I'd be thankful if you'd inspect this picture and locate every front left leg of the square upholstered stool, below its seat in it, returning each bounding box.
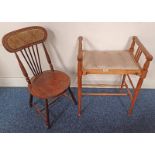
[78,73,82,116]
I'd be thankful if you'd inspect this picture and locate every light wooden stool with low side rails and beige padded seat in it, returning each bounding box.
[77,36,153,116]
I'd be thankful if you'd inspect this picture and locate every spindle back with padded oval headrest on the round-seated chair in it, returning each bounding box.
[2,26,53,84]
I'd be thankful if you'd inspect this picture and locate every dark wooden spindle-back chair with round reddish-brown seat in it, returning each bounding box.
[2,26,75,128]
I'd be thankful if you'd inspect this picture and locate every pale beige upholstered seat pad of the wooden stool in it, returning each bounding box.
[83,51,140,74]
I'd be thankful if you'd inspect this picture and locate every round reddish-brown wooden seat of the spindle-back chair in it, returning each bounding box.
[28,70,70,98]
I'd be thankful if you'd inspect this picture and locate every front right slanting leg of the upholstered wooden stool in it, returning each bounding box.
[128,78,144,115]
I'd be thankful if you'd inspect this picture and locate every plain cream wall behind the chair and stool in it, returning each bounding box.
[0,22,155,88]
